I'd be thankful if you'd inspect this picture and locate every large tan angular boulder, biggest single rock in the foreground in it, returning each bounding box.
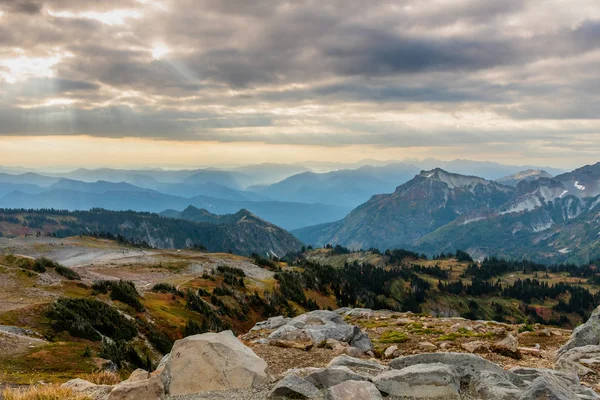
[161,331,270,396]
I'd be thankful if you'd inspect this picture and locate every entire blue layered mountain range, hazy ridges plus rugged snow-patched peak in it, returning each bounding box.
[0,160,600,262]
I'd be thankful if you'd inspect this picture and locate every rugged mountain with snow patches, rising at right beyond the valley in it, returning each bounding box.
[293,163,600,262]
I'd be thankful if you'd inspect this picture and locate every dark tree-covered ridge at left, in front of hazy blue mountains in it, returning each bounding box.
[0,209,302,256]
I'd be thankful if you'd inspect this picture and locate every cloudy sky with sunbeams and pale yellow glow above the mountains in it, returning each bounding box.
[0,0,600,167]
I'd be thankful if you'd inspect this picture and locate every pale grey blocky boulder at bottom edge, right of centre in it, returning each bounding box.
[373,363,460,399]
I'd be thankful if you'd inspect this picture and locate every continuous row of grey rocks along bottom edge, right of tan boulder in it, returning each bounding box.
[272,353,600,400]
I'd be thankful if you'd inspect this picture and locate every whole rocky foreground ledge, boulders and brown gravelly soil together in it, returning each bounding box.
[57,307,600,400]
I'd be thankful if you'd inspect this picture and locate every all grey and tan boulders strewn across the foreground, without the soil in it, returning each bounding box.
[65,307,600,400]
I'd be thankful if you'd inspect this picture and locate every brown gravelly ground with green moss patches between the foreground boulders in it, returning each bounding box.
[242,309,571,373]
